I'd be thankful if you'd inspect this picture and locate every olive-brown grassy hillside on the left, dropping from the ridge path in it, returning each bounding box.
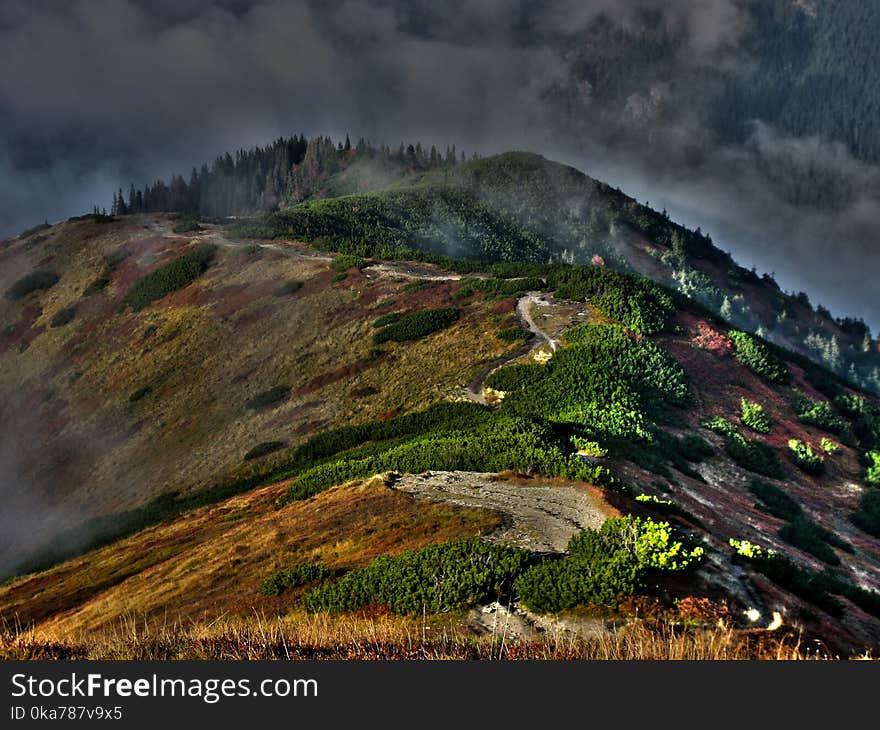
[0,216,513,556]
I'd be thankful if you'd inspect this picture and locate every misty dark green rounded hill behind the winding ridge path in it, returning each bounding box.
[237,145,880,392]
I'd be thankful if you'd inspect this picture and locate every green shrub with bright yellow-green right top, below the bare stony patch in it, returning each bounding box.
[516,516,703,613]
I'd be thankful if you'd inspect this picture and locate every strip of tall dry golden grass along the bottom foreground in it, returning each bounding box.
[0,613,852,661]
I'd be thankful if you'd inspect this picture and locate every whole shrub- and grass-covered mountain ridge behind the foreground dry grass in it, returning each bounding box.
[0,148,880,653]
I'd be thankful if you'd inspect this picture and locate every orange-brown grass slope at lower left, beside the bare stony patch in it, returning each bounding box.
[0,478,500,636]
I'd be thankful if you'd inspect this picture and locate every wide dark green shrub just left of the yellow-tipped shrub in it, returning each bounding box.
[305,539,534,614]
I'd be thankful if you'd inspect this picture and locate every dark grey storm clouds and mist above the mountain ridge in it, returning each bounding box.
[0,0,880,330]
